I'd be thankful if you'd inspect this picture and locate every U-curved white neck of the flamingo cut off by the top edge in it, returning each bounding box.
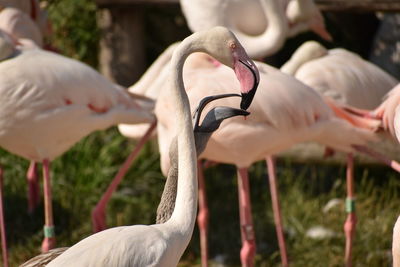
[235,0,288,58]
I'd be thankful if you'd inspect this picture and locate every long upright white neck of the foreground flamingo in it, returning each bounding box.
[167,37,198,239]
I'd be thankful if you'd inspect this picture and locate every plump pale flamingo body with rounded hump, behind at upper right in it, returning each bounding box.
[281,41,398,109]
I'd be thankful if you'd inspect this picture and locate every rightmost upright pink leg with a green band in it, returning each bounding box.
[344,154,357,267]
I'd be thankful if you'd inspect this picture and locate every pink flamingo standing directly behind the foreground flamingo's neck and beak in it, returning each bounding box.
[155,52,400,266]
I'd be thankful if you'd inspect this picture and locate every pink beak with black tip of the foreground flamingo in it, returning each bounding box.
[235,59,260,110]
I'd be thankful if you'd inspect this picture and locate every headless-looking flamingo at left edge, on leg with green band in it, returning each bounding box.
[0,35,154,267]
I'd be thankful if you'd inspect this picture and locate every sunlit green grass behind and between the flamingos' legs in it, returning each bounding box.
[0,132,400,266]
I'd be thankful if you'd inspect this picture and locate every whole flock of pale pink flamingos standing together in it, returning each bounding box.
[0,0,400,267]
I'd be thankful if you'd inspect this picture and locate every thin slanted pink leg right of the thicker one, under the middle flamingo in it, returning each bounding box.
[266,156,289,267]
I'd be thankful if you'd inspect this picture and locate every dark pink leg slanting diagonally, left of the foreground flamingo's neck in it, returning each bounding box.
[92,122,157,233]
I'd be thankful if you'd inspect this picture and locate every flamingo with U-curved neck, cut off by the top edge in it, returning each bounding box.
[180,0,330,58]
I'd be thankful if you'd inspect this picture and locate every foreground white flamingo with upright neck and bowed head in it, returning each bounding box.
[21,27,257,267]
